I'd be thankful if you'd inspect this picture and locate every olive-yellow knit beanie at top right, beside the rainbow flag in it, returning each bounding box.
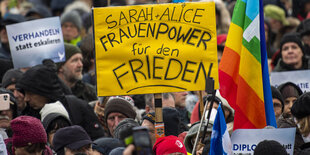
[264,4,289,26]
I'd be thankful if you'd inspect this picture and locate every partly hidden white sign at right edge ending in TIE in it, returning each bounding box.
[270,70,310,92]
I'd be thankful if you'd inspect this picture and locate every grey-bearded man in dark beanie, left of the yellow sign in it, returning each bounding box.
[57,43,97,102]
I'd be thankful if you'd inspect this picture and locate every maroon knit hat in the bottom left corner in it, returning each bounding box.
[11,116,47,147]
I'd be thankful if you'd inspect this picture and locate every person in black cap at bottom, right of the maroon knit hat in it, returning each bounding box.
[53,125,92,155]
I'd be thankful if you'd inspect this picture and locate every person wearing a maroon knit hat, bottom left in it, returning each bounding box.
[7,116,52,155]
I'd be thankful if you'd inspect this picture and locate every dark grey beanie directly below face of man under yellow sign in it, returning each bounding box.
[113,118,140,140]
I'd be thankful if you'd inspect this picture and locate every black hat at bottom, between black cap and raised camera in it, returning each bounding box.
[92,137,124,154]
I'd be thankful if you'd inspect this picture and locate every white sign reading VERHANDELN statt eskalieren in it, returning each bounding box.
[6,17,65,68]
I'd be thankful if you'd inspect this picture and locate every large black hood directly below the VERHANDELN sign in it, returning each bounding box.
[16,65,63,101]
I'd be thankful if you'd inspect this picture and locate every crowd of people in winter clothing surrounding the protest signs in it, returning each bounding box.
[0,0,310,155]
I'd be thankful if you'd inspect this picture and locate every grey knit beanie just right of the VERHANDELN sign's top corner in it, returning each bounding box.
[60,11,83,31]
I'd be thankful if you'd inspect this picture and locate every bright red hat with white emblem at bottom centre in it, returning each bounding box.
[153,136,187,155]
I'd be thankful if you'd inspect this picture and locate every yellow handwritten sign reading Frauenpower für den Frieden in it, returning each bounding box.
[93,2,218,96]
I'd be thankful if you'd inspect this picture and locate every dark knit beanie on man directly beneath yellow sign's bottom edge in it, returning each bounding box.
[104,97,137,121]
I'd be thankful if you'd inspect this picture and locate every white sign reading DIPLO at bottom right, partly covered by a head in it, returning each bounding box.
[231,128,296,155]
